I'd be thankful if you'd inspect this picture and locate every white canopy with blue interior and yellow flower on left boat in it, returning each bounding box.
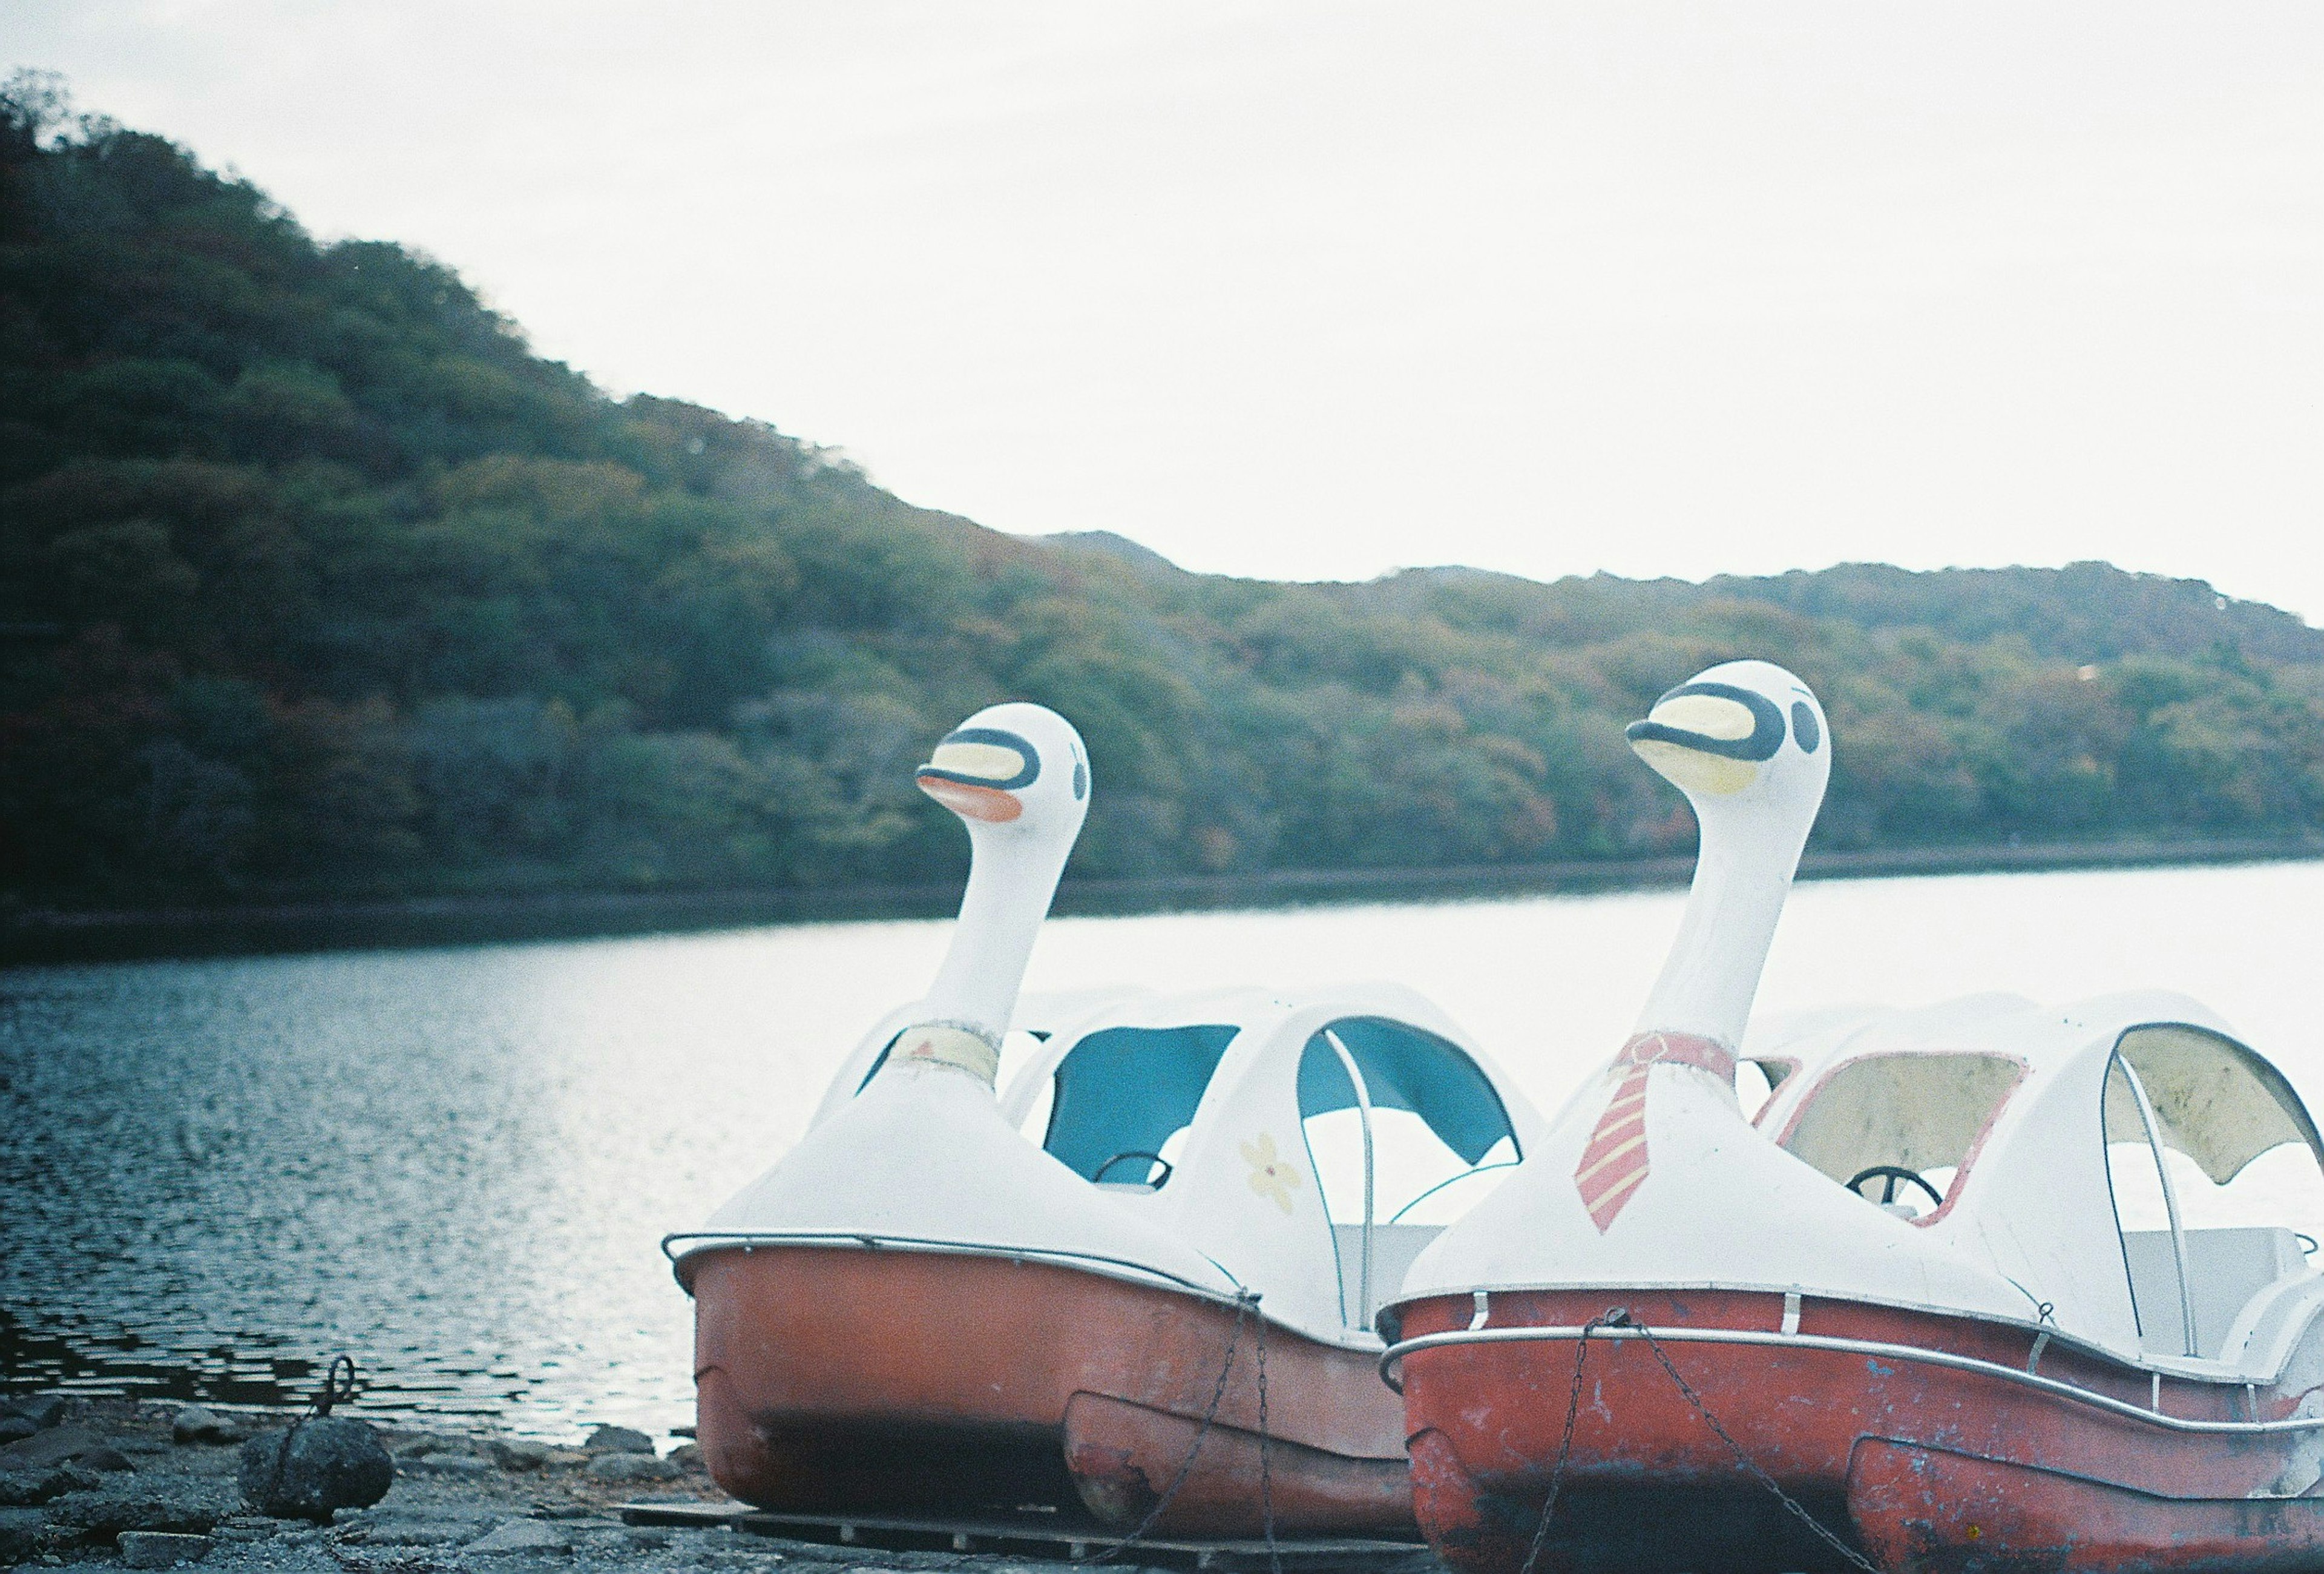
[1002,984,1534,1342]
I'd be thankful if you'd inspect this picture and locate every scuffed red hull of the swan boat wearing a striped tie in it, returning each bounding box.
[1402,1290,2317,1574]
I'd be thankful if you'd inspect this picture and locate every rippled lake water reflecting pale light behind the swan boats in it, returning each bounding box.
[0,863,2324,1437]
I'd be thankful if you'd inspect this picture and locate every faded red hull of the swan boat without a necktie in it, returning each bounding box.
[686,1246,1413,1537]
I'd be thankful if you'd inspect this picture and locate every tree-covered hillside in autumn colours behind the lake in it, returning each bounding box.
[13,79,2324,904]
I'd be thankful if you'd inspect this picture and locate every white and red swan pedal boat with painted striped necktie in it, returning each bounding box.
[1383,663,2324,1574]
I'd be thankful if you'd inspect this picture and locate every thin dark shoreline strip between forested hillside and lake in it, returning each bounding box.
[0,837,2324,967]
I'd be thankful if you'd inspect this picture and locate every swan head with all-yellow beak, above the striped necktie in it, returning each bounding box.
[1629,660,1831,837]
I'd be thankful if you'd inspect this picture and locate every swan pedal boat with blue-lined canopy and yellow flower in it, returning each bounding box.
[665,705,1541,1537]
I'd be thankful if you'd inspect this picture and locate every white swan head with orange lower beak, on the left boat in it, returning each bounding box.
[916,700,1090,846]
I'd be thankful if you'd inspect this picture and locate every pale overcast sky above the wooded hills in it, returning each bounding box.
[13,0,2324,621]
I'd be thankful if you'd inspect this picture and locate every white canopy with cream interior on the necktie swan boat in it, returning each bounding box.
[1750,993,2324,1365]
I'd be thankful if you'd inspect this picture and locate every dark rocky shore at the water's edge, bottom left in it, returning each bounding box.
[0,1397,1315,1574]
